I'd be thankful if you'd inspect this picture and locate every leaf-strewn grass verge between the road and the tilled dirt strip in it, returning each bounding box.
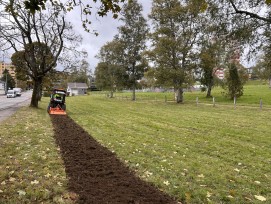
[0,102,72,204]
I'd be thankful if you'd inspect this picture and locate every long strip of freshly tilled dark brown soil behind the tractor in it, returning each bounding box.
[51,115,177,204]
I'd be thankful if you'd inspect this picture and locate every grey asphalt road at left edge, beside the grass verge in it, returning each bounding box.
[0,91,32,122]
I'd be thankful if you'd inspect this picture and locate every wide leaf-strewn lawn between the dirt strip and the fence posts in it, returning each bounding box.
[67,93,271,203]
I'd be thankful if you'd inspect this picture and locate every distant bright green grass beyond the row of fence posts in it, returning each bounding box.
[91,81,271,107]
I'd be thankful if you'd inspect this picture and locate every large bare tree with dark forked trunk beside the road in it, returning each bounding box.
[0,0,81,107]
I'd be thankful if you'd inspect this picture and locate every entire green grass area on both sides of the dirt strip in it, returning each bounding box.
[0,84,271,204]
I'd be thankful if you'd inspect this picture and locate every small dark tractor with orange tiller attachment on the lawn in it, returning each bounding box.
[47,89,67,115]
